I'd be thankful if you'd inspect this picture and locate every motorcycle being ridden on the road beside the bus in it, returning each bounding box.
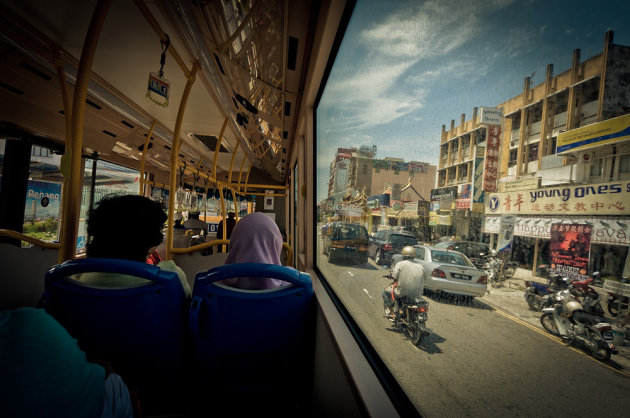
[385,275,431,346]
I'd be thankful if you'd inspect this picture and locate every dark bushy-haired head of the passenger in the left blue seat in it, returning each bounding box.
[86,195,166,261]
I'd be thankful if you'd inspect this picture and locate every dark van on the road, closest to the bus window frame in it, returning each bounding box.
[322,222,368,264]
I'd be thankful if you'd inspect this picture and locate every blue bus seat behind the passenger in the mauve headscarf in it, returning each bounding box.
[189,263,314,394]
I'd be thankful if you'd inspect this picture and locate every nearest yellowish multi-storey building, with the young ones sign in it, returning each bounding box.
[482,32,630,275]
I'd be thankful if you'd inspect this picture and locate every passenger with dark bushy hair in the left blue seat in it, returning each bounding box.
[75,195,191,298]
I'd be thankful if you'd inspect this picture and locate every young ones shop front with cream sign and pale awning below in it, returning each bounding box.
[483,181,630,277]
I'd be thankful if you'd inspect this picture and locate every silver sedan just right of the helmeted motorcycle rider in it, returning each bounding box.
[392,245,488,296]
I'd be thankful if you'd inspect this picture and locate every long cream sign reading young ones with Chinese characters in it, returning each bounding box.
[486,181,630,216]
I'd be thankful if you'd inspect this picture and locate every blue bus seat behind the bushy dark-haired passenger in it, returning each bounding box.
[41,258,189,386]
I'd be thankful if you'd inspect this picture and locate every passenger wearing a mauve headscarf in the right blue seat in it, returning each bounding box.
[219,212,287,290]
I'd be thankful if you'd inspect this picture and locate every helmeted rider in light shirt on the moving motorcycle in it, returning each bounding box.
[383,246,424,319]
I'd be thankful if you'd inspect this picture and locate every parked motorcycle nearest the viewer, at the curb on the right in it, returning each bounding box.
[540,291,618,361]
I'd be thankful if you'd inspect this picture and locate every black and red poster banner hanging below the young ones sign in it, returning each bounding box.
[549,223,593,280]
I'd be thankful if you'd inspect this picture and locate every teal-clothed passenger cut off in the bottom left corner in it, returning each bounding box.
[0,308,133,418]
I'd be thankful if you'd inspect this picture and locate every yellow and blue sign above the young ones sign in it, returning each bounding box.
[556,114,630,154]
